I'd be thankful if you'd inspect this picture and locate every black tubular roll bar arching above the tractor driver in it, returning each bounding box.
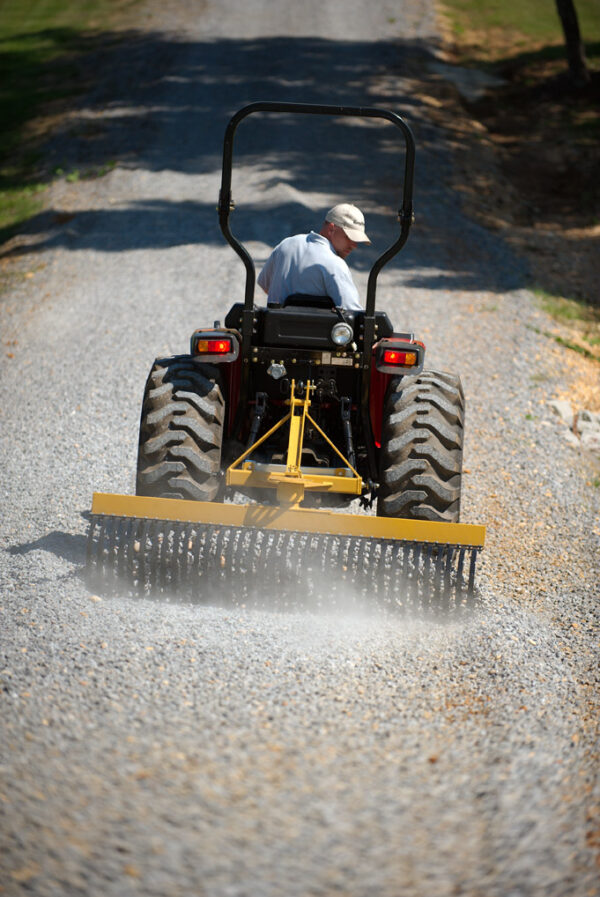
[218,101,415,318]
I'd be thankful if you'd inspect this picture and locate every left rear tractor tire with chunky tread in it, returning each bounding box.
[136,355,225,501]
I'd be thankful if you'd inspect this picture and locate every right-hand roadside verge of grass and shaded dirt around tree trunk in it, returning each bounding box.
[440,0,600,370]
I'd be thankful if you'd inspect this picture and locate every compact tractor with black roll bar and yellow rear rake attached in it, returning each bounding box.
[87,102,485,607]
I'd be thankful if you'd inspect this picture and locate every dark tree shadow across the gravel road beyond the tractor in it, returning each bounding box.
[0,33,524,291]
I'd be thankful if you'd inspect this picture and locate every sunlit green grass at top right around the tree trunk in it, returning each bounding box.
[442,0,600,52]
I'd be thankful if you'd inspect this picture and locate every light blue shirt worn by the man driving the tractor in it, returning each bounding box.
[258,231,362,310]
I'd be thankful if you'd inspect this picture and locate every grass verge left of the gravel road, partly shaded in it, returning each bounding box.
[0,0,137,241]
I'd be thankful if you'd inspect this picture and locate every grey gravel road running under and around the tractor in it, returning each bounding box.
[0,0,600,897]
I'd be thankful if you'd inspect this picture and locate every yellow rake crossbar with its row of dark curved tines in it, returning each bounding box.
[87,493,484,609]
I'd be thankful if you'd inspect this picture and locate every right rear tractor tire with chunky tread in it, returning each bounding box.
[377,371,465,523]
